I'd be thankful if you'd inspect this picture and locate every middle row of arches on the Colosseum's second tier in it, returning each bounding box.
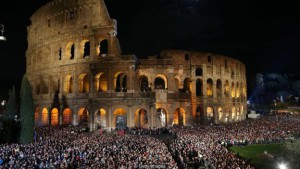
[36,72,246,99]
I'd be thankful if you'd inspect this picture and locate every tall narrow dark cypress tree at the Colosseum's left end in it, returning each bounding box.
[20,75,34,144]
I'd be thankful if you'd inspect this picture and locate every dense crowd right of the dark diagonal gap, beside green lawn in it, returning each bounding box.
[169,115,300,169]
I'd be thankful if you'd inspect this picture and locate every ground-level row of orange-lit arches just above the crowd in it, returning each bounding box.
[35,106,245,129]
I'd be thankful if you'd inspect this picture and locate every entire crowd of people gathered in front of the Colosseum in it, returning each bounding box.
[0,116,300,169]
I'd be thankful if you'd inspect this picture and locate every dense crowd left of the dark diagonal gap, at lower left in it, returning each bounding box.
[0,127,177,169]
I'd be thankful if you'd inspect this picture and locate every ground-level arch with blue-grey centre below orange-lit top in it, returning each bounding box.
[112,108,127,129]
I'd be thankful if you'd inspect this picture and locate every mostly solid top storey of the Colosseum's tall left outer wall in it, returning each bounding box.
[27,0,117,47]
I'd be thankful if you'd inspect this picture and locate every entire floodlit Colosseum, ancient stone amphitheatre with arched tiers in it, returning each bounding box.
[26,0,247,130]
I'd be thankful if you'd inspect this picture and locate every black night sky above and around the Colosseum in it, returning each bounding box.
[0,0,300,97]
